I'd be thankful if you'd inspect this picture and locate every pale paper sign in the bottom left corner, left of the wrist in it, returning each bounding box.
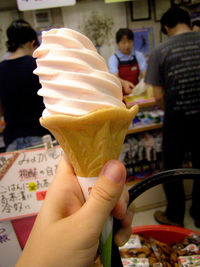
[0,221,21,267]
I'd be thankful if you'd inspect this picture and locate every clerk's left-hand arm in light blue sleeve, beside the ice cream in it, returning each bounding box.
[108,55,135,95]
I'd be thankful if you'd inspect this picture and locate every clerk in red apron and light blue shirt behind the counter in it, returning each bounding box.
[108,28,147,95]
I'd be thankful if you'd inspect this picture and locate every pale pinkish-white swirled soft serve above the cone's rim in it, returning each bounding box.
[33,28,125,117]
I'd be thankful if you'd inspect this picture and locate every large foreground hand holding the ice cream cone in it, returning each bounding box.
[16,158,134,267]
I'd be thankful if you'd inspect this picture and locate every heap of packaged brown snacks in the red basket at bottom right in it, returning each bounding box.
[120,234,200,267]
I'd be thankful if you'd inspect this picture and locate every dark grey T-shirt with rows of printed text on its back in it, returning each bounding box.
[145,32,200,118]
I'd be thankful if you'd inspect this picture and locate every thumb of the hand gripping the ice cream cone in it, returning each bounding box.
[84,160,126,234]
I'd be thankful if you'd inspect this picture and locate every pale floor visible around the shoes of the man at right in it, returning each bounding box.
[133,200,200,232]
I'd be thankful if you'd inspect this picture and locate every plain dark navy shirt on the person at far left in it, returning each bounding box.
[0,56,49,146]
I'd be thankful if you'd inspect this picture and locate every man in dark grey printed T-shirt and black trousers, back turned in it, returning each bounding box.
[145,7,200,227]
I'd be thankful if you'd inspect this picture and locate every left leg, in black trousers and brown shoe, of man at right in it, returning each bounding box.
[154,118,185,226]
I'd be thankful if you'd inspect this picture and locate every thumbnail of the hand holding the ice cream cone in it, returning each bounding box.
[101,160,123,184]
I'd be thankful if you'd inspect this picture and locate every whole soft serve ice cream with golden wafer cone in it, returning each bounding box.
[34,28,138,266]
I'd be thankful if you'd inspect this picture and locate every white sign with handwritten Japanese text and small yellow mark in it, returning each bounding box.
[0,146,62,221]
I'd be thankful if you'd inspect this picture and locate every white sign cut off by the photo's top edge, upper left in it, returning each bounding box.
[17,0,76,11]
